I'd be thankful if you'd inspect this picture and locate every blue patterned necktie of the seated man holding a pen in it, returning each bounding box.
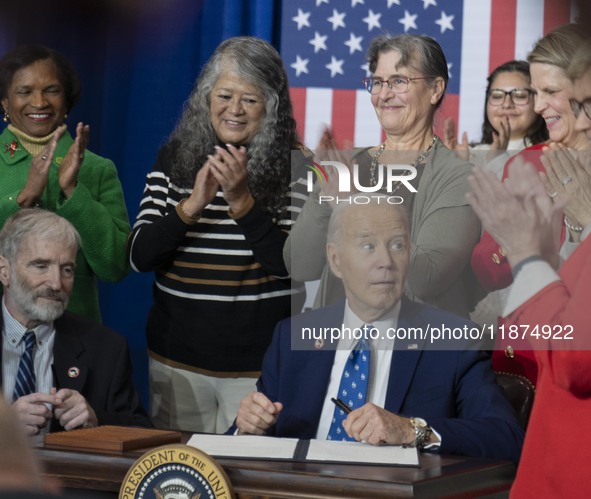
[326,326,371,441]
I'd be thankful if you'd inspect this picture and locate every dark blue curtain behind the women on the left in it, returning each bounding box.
[0,0,280,402]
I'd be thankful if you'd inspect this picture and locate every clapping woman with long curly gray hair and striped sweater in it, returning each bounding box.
[128,37,304,432]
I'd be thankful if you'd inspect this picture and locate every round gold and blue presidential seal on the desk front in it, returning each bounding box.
[119,444,235,499]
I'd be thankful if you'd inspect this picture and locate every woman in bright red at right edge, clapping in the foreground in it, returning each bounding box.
[470,40,591,492]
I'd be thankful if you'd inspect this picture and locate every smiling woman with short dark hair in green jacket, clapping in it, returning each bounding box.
[0,45,129,321]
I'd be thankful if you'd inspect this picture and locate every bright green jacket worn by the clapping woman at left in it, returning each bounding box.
[0,125,130,321]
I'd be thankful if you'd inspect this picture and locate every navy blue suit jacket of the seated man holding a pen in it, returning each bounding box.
[258,299,524,461]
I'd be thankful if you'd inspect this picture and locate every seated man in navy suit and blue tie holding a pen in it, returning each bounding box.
[236,196,524,462]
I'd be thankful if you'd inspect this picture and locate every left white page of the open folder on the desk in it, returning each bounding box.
[187,434,299,459]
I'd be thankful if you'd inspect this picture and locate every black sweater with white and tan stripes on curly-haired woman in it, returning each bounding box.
[129,146,306,373]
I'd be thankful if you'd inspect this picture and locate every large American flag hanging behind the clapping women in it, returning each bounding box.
[281,0,576,148]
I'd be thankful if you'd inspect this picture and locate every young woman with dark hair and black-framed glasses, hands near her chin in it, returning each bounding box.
[444,61,548,178]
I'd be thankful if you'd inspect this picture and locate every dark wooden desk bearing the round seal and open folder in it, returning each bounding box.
[35,437,515,499]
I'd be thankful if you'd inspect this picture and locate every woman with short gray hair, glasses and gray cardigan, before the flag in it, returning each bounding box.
[284,35,480,317]
